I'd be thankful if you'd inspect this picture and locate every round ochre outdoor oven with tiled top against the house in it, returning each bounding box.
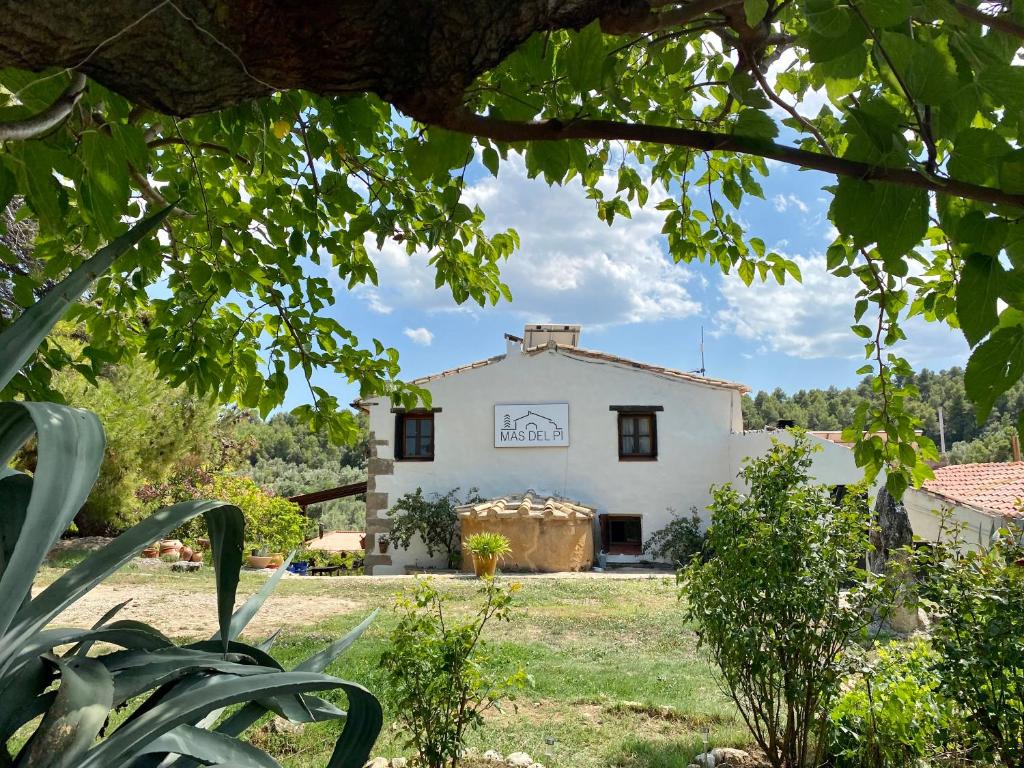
[458,490,594,572]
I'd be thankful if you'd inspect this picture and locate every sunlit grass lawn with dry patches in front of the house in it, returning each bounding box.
[40,567,750,768]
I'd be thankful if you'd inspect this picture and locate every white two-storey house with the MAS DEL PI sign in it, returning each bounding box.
[357,326,862,573]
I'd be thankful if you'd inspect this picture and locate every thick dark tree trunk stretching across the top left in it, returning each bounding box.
[0,0,638,117]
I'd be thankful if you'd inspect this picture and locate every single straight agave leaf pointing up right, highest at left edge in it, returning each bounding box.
[0,206,173,389]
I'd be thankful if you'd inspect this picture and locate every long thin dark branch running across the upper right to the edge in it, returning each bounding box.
[440,111,1024,208]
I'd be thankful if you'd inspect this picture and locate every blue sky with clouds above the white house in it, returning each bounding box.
[286,151,968,415]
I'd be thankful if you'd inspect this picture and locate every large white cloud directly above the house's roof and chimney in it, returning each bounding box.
[355,158,700,329]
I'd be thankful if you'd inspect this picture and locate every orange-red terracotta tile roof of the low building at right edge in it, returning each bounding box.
[923,462,1024,517]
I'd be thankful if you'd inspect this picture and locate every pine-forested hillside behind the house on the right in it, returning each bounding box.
[743,368,1024,464]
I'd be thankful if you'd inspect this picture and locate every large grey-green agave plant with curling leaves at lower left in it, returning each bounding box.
[0,211,382,768]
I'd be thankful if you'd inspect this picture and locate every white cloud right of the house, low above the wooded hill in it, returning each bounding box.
[715,255,969,368]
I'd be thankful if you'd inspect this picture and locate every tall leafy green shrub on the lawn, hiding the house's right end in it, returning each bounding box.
[681,434,876,768]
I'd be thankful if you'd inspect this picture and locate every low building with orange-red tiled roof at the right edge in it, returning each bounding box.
[903,462,1024,548]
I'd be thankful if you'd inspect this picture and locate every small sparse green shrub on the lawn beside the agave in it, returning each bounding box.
[381,580,526,768]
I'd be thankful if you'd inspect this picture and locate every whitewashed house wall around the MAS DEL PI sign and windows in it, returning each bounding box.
[370,349,861,573]
